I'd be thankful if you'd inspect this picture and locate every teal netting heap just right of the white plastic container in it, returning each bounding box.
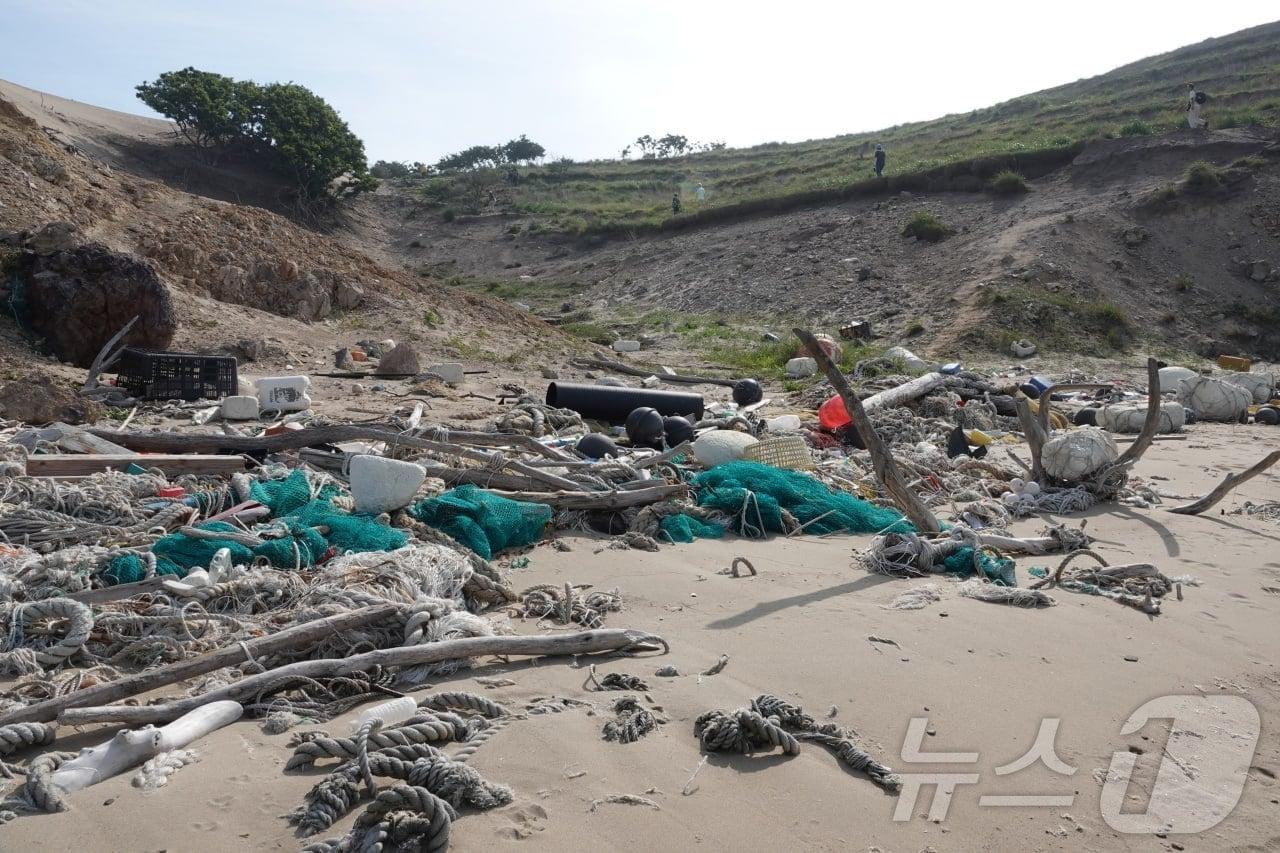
[410,485,552,560]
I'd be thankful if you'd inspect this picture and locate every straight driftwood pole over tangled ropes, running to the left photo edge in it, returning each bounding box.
[0,596,399,726]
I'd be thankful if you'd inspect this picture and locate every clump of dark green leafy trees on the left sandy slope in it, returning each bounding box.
[137,68,376,202]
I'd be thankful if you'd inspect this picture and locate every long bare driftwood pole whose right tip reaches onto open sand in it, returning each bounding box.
[59,628,667,725]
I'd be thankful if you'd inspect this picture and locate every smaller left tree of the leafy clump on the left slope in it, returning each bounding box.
[136,68,256,149]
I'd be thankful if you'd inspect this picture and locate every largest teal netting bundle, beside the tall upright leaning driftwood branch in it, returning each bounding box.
[692,461,913,538]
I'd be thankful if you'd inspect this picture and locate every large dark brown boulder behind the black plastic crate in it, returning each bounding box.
[14,243,178,368]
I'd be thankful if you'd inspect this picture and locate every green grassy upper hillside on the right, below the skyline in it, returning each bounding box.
[403,22,1280,233]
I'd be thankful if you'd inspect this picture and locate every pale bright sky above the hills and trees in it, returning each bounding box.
[0,0,1280,161]
